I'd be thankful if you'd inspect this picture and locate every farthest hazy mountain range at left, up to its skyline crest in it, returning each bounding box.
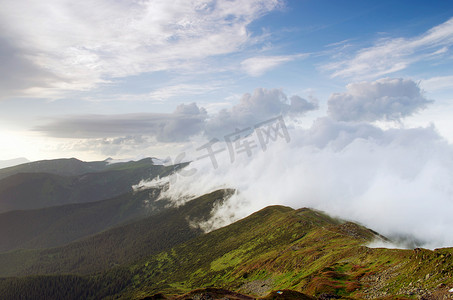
[0,158,183,213]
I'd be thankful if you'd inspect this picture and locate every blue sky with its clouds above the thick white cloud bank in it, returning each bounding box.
[0,0,453,160]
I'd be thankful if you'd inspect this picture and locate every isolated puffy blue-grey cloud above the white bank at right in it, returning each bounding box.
[328,78,432,122]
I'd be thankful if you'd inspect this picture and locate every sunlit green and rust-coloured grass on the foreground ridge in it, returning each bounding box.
[116,207,453,297]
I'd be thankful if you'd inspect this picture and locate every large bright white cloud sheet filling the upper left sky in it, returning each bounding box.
[0,0,281,97]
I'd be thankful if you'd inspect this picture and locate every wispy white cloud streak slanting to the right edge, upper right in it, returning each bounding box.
[323,18,453,79]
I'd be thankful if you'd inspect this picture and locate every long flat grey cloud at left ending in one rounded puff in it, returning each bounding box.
[34,103,207,142]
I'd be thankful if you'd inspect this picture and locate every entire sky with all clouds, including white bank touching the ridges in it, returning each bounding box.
[0,0,453,248]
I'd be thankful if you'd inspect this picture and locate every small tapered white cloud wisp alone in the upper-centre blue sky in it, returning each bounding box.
[241,54,307,76]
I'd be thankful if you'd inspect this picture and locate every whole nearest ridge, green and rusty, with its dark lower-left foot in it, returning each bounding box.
[0,203,453,299]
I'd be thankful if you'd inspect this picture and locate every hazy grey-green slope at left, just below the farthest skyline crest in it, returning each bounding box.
[0,159,183,212]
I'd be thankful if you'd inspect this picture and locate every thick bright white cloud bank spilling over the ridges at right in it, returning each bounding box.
[134,79,453,248]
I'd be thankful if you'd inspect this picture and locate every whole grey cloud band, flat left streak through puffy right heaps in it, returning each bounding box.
[34,88,318,143]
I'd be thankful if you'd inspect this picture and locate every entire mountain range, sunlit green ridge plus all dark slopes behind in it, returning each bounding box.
[0,158,453,299]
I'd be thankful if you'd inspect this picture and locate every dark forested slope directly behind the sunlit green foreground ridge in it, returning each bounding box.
[0,190,229,276]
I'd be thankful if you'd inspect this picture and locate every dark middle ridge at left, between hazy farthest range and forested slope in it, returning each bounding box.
[0,189,167,252]
